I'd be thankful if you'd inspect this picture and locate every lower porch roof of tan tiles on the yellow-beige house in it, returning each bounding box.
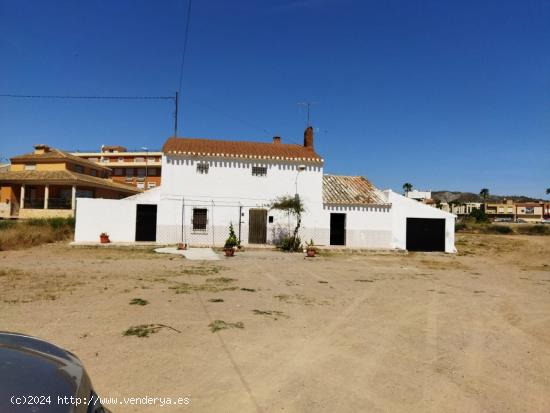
[0,170,141,194]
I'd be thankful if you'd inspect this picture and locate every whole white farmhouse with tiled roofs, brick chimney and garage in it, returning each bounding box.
[75,127,455,252]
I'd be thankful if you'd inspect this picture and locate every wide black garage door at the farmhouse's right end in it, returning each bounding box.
[407,218,445,251]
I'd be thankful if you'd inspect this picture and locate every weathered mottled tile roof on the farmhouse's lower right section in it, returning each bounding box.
[323,175,388,205]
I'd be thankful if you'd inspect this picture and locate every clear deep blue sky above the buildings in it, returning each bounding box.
[0,0,550,197]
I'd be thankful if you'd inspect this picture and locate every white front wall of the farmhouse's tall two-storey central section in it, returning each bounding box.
[157,155,326,245]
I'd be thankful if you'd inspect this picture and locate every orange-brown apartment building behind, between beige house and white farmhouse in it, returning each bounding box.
[72,145,162,189]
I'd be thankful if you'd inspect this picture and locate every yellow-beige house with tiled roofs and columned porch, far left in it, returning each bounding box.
[0,145,140,218]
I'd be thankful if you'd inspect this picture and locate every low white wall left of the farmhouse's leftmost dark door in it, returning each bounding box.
[75,198,136,242]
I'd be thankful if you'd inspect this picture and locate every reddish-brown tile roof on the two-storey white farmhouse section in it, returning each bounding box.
[162,138,323,162]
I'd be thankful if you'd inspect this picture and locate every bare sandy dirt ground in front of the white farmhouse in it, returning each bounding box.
[0,235,550,413]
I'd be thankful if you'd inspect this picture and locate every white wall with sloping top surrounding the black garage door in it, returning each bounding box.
[384,190,456,253]
